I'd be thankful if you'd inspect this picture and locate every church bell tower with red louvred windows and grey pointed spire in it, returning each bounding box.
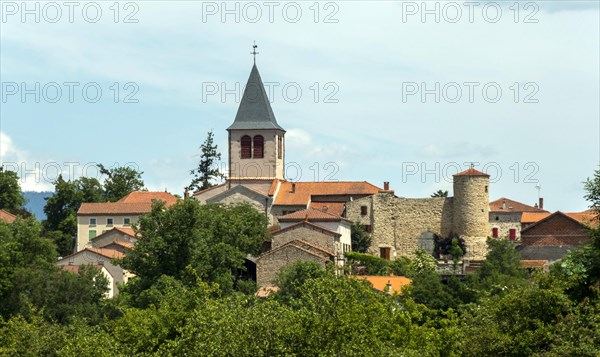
[227,50,285,179]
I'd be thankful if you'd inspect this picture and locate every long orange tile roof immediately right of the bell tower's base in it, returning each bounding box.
[274,181,381,206]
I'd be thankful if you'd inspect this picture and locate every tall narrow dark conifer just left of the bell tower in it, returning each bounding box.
[188,130,225,191]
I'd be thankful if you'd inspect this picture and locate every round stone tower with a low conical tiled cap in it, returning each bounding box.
[452,168,490,260]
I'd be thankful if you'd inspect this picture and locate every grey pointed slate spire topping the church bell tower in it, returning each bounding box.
[227,64,285,131]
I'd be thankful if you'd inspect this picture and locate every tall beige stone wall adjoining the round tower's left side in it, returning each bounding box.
[347,192,453,259]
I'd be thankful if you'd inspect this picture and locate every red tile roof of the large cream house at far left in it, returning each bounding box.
[77,191,178,215]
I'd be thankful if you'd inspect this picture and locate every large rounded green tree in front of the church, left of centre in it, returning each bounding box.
[123,200,269,295]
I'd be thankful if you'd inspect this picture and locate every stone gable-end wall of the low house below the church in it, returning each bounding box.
[256,244,330,287]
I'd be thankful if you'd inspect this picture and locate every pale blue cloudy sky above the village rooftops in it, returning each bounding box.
[0,1,600,211]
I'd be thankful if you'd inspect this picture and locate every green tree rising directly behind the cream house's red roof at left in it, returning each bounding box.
[98,164,144,202]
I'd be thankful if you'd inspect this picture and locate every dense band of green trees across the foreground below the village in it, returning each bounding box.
[0,171,600,356]
